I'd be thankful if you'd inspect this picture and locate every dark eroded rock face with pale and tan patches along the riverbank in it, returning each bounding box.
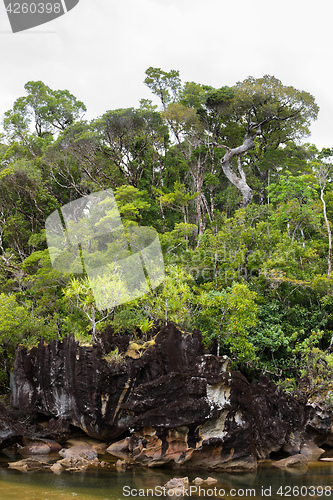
[8,324,312,470]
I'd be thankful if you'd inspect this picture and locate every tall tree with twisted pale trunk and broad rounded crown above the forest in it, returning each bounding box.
[208,75,319,206]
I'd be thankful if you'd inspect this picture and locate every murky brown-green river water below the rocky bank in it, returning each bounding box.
[0,462,333,500]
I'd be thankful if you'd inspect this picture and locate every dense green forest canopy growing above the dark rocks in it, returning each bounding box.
[0,68,333,398]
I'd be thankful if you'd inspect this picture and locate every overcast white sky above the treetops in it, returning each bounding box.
[0,0,333,148]
